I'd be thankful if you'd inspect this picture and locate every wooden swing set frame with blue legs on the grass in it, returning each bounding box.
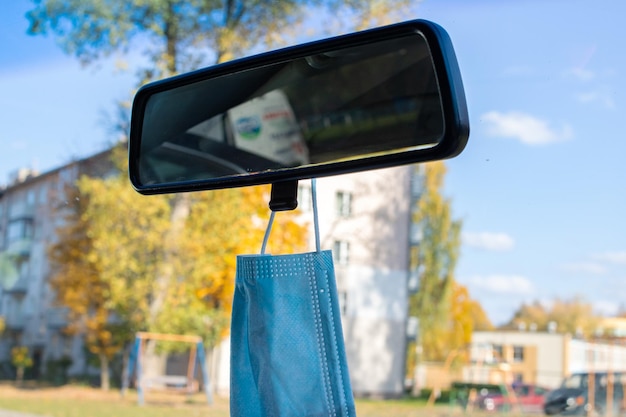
[122,332,213,405]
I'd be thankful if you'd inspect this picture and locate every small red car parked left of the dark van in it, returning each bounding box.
[477,384,548,413]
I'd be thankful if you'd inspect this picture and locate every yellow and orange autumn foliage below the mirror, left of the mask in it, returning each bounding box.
[50,148,307,370]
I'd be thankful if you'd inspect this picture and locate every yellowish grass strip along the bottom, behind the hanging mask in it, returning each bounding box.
[0,385,460,417]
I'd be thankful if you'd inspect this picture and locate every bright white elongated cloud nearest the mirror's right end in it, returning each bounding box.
[481,111,573,145]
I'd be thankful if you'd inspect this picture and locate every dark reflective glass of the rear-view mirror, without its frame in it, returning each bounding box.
[138,32,445,185]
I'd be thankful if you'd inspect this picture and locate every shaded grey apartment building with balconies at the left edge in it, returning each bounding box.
[0,152,112,378]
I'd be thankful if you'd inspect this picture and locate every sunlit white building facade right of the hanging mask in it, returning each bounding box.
[318,166,416,396]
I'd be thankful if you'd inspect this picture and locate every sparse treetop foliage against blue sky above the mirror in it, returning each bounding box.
[27,0,409,82]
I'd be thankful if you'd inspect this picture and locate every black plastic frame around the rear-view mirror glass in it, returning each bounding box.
[129,20,469,194]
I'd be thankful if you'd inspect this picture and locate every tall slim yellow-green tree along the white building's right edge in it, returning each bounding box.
[410,162,461,360]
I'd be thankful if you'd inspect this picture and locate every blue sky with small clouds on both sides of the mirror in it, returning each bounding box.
[0,0,626,323]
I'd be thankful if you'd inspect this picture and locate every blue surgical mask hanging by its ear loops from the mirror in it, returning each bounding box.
[230,180,356,417]
